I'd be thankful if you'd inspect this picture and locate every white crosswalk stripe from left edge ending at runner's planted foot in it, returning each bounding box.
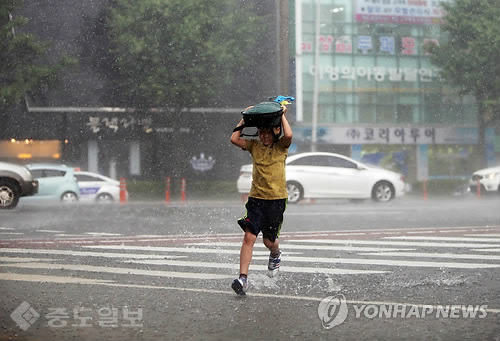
[2,263,234,279]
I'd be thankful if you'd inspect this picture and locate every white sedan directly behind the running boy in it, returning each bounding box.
[237,152,405,203]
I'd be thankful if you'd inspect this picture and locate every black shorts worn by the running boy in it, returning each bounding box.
[238,197,288,242]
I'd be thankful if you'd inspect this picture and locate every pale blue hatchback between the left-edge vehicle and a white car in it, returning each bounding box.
[26,163,80,202]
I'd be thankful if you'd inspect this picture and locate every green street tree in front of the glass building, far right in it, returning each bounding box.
[426,0,500,166]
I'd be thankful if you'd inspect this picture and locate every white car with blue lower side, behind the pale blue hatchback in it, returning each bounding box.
[75,171,124,202]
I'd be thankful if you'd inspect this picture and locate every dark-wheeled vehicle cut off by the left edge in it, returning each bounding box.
[0,162,38,209]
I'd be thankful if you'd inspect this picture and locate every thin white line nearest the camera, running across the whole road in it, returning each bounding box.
[0,273,500,314]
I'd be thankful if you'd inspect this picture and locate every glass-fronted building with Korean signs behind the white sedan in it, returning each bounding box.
[294,0,500,182]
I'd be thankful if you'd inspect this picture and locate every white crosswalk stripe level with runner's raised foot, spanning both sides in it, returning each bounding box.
[122,257,388,275]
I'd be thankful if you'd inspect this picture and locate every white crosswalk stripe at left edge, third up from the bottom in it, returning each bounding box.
[0,248,187,259]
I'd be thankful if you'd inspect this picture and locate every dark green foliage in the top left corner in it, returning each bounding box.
[0,0,74,108]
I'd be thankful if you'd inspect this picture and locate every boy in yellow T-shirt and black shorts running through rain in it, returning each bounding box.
[231,106,293,295]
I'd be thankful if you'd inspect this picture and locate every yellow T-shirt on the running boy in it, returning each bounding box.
[247,139,288,200]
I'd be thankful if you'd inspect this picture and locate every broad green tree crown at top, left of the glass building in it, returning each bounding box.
[108,0,266,111]
